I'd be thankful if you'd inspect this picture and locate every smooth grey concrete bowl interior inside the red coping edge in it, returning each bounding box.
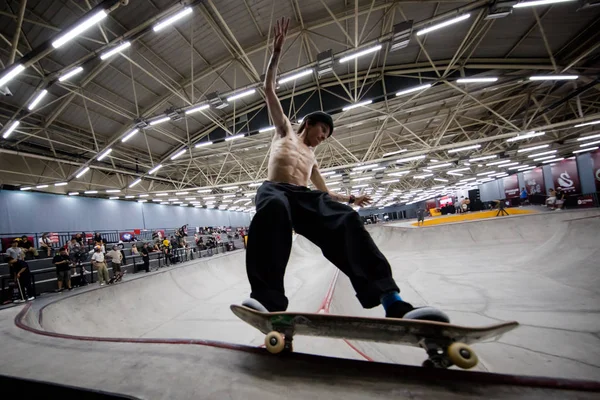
[18,210,600,379]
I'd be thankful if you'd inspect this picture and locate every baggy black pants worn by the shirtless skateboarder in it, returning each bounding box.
[246,181,399,311]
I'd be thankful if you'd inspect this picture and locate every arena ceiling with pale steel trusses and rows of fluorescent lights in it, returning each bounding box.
[0,0,600,211]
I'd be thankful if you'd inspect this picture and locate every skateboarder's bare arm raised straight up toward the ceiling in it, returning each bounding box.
[265,18,291,137]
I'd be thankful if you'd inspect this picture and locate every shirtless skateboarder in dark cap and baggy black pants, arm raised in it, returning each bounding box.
[243,18,448,322]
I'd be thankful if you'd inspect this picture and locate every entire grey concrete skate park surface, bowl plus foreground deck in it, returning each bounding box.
[0,209,600,399]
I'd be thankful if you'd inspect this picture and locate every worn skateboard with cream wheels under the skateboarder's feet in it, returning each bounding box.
[230,304,519,369]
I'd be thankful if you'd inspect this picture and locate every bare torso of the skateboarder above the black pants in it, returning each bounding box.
[267,121,316,186]
